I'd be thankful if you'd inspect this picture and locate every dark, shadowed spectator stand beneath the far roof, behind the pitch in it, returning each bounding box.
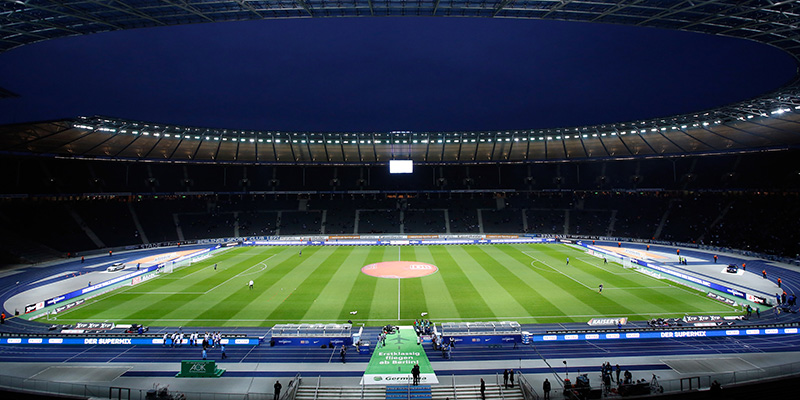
[0,151,800,257]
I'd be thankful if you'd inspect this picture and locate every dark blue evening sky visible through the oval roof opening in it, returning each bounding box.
[0,18,796,131]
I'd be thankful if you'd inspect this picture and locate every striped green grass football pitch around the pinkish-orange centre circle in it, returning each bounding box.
[51,244,736,326]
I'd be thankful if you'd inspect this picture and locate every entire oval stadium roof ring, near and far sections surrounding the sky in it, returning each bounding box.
[0,0,800,163]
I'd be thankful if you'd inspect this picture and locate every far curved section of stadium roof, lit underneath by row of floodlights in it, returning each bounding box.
[0,109,800,163]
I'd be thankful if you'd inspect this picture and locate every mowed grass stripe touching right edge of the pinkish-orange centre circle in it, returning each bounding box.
[430,246,496,319]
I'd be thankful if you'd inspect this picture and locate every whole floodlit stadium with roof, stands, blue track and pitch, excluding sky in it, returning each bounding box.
[0,0,800,400]
